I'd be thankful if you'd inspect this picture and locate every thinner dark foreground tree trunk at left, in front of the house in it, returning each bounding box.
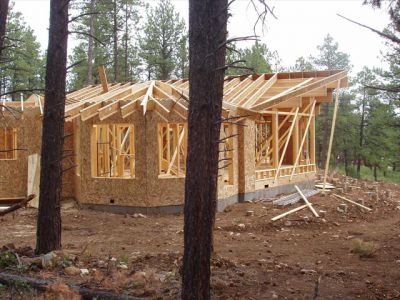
[36,0,69,254]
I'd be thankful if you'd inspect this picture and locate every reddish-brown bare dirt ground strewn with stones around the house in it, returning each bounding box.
[0,178,400,299]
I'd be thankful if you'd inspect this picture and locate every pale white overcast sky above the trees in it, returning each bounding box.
[15,0,389,71]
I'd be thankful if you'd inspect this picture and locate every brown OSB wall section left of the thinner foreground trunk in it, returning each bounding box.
[0,108,42,198]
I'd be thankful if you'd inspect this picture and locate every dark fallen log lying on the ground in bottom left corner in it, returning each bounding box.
[0,273,146,300]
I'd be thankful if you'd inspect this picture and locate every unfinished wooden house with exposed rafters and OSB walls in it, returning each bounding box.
[0,70,347,212]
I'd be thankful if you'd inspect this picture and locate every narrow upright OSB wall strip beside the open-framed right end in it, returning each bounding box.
[237,119,256,193]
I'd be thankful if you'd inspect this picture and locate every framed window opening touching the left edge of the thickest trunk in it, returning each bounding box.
[158,123,187,178]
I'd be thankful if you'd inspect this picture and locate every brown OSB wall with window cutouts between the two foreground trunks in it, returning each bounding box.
[75,110,186,207]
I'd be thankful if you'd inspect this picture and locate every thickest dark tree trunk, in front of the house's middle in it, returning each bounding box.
[182,0,228,300]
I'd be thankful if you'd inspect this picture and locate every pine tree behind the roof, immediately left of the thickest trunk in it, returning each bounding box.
[139,0,187,80]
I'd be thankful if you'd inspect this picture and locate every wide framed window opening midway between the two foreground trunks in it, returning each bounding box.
[91,124,135,178]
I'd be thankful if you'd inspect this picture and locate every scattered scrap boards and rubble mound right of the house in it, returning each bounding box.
[271,175,400,221]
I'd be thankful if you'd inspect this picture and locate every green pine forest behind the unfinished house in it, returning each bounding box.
[0,0,400,182]
